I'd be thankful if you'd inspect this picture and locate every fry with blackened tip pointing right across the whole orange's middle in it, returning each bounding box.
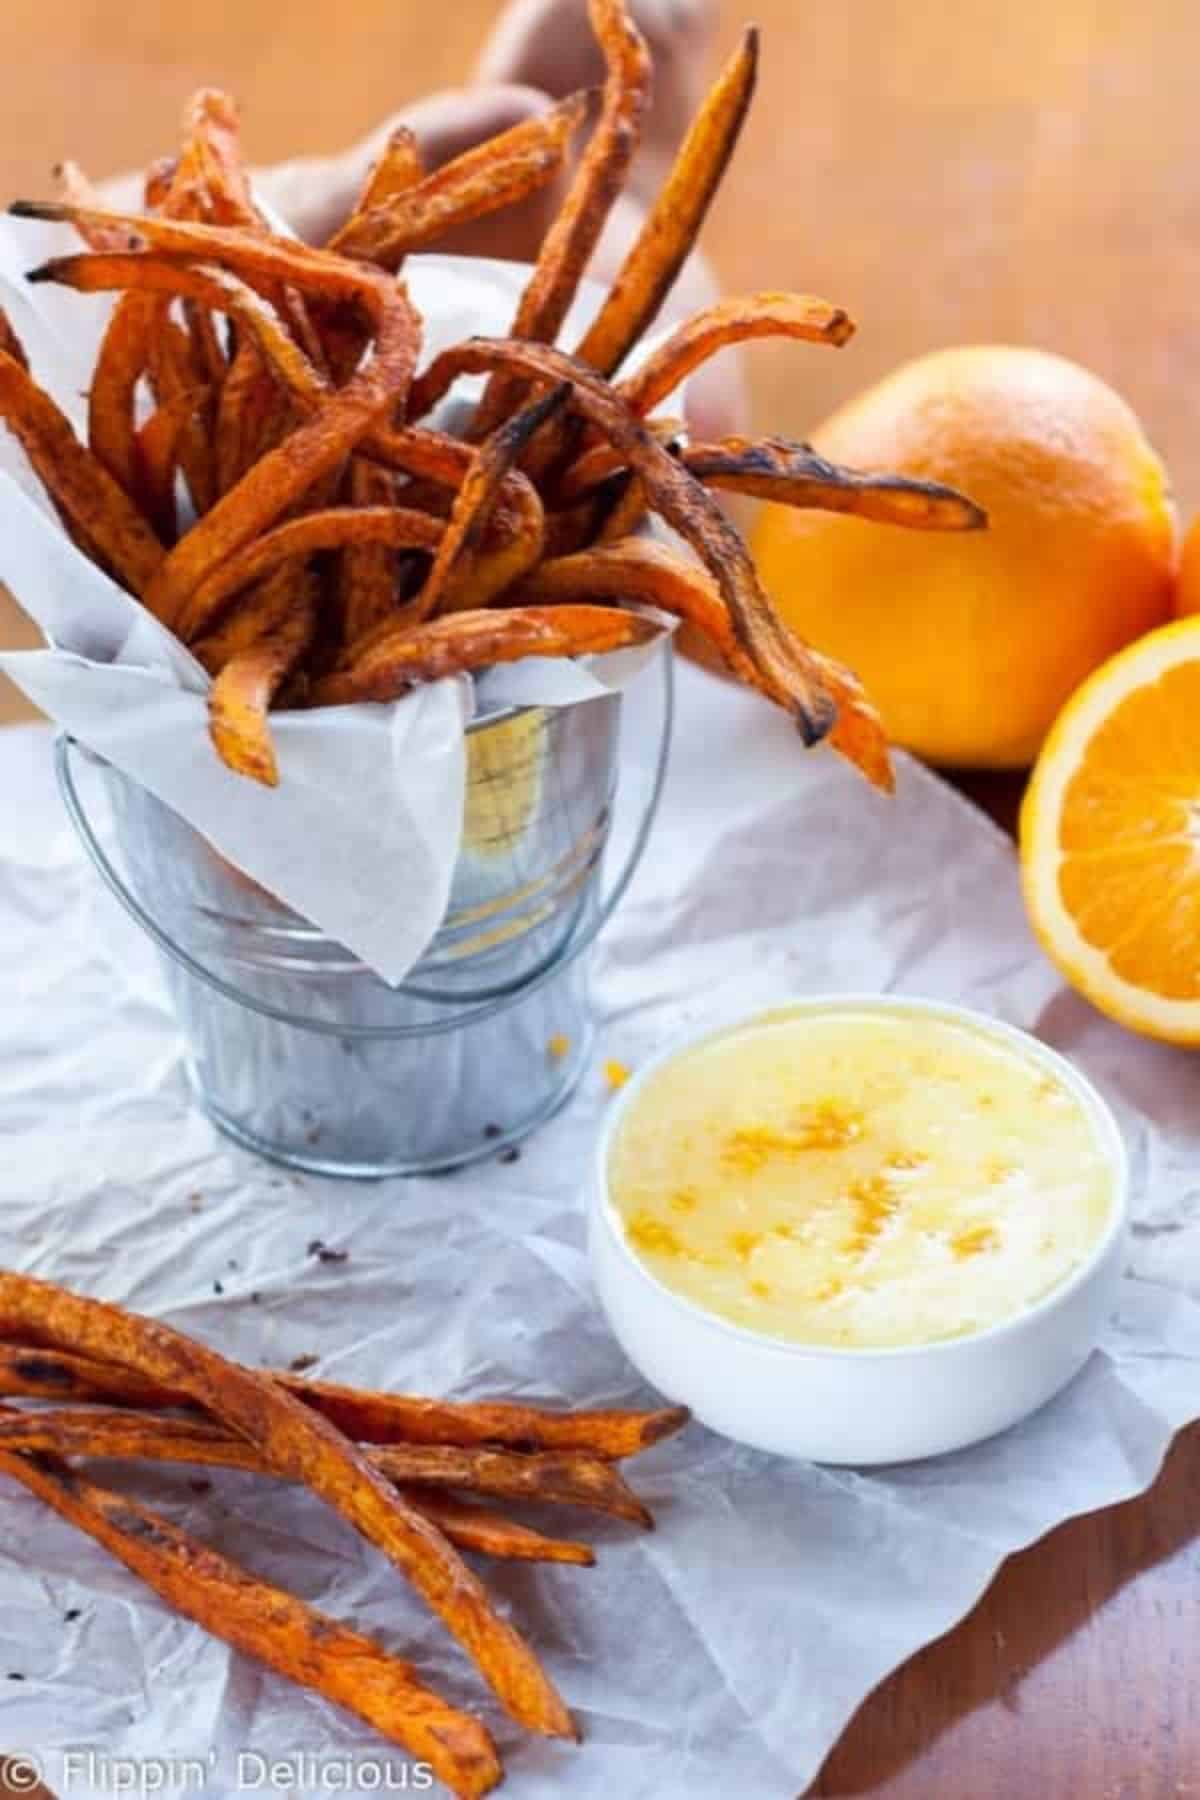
[678,437,988,531]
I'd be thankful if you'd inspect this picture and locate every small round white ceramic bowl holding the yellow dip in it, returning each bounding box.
[588,994,1128,1465]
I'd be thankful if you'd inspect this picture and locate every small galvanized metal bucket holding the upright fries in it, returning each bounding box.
[58,643,671,1177]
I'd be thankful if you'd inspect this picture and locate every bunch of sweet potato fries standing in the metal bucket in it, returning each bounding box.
[0,0,984,787]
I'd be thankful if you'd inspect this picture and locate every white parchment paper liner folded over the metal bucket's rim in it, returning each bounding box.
[0,216,672,983]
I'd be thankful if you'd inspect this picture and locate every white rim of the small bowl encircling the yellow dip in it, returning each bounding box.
[592,988,1130,1363]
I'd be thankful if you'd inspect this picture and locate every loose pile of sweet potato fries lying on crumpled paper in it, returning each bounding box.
[0,1271,687,1795]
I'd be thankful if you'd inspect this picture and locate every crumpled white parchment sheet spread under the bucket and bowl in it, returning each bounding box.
[0,670,1200,1800]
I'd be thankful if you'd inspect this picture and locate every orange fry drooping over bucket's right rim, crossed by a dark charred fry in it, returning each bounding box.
[516,538,892,792]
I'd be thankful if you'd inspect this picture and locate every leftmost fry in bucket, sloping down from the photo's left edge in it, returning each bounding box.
[0,351,164,596]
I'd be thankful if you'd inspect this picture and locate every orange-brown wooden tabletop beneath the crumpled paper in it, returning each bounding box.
[0,0,1200,1800]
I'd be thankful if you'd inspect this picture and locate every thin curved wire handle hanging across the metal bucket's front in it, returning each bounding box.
[54,643,675,1039]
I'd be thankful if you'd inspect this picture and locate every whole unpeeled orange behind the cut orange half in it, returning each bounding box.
[756,346,1175,769]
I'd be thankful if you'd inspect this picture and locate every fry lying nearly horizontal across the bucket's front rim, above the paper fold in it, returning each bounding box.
[311,607,658,706]
